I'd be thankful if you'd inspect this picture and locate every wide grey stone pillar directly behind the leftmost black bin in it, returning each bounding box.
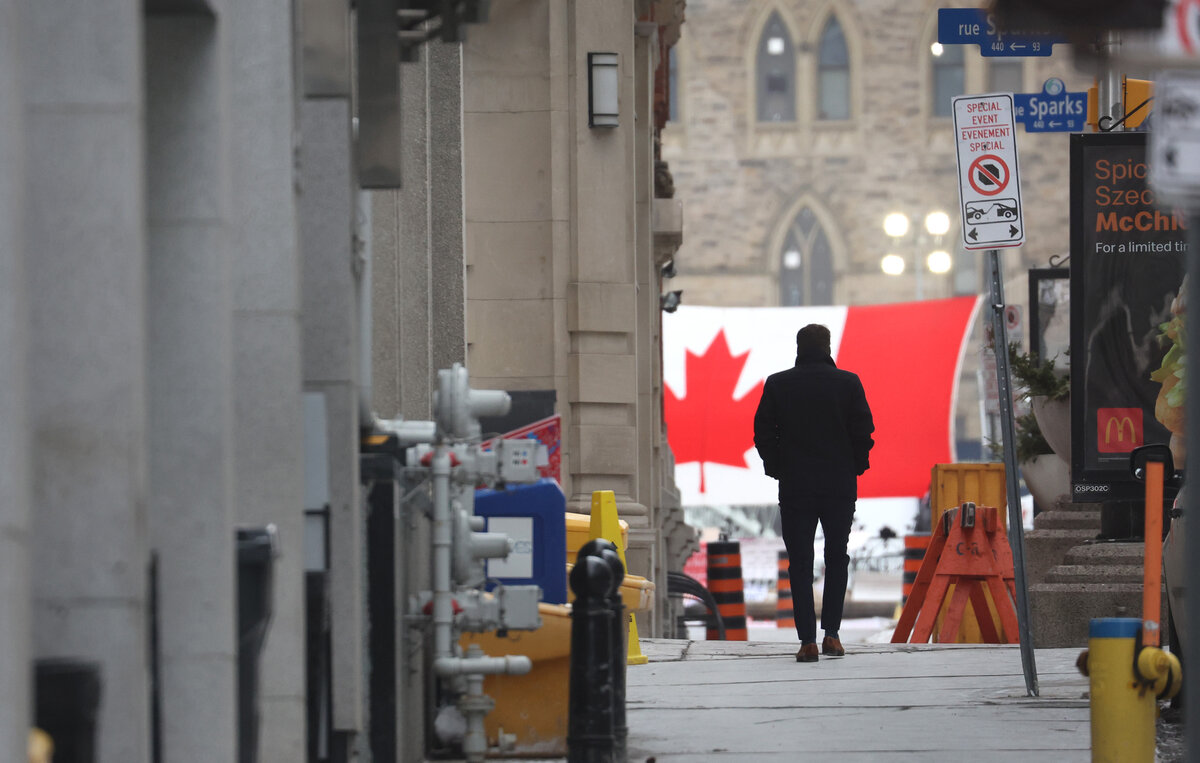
[23,0,150,763]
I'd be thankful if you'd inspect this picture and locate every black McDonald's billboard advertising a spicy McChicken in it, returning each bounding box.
[1070,132,1187,501]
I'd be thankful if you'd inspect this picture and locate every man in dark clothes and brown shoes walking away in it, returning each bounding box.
[754,323,875,662]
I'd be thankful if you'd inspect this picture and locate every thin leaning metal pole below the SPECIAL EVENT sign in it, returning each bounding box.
[988,250,1038,697]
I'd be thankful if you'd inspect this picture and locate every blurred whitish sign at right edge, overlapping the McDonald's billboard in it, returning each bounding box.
[1150,71,1200,210]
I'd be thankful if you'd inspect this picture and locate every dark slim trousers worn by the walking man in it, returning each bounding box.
[779,495,854,643]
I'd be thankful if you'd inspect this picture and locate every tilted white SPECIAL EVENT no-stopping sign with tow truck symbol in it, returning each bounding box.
[953,92,1025,250]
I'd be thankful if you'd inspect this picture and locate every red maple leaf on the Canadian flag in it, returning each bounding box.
[665,329,762,493]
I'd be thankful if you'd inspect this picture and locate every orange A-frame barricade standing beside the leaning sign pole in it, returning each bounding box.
[892,503,1019,644]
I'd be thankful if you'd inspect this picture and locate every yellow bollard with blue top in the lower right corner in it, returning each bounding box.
[1081,618,1165,763]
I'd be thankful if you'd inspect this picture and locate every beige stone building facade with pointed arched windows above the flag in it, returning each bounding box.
[662,0,1091,306]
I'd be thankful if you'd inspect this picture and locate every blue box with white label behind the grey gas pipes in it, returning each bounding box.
[475,477,566,603]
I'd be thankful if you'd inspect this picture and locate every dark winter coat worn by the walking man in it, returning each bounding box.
[754,353,875,498]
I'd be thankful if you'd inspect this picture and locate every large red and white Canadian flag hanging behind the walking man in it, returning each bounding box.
[662,296,983,506]
